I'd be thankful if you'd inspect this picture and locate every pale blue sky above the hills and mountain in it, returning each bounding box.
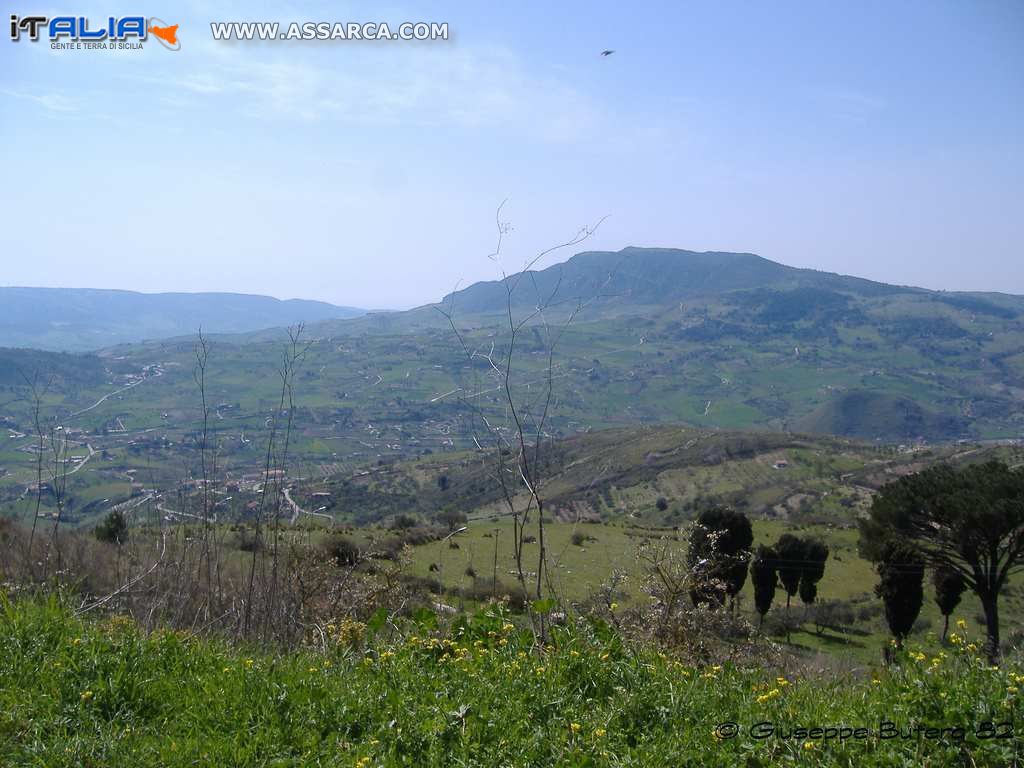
[0,0,1024,309]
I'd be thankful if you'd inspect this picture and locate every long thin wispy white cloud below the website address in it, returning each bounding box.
[124,35,609,141]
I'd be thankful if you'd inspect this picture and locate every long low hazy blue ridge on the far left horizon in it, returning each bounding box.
[0,288,364,351]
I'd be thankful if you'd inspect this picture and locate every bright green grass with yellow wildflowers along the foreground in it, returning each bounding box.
[0,596,1024,767]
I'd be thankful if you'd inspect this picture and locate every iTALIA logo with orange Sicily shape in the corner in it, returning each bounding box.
[10,13,181,50]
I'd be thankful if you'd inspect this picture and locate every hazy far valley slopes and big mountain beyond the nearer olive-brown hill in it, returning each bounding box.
[0,249,1024,536]
